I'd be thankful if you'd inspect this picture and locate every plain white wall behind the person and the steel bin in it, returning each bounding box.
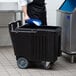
[0,0,64,25]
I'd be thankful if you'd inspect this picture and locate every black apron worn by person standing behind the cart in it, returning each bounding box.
[27,0,47,25]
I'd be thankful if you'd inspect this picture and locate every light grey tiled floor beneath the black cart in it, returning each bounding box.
[0,47,76,76]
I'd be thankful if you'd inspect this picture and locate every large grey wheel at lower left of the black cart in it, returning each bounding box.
[17,57,29,69]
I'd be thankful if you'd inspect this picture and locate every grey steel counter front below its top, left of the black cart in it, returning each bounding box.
[0,10,23,46]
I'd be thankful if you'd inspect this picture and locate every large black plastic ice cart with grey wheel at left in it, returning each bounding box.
[9,21,61,69]
